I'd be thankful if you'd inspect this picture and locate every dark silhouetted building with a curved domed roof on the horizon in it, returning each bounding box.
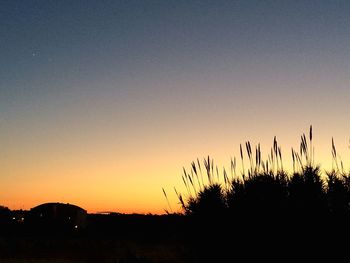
[29,203,87,229]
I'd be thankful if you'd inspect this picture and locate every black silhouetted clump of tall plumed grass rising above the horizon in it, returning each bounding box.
[168,126,350,220]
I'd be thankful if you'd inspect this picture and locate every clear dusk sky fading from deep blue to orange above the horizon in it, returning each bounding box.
[0,0,350,214]
